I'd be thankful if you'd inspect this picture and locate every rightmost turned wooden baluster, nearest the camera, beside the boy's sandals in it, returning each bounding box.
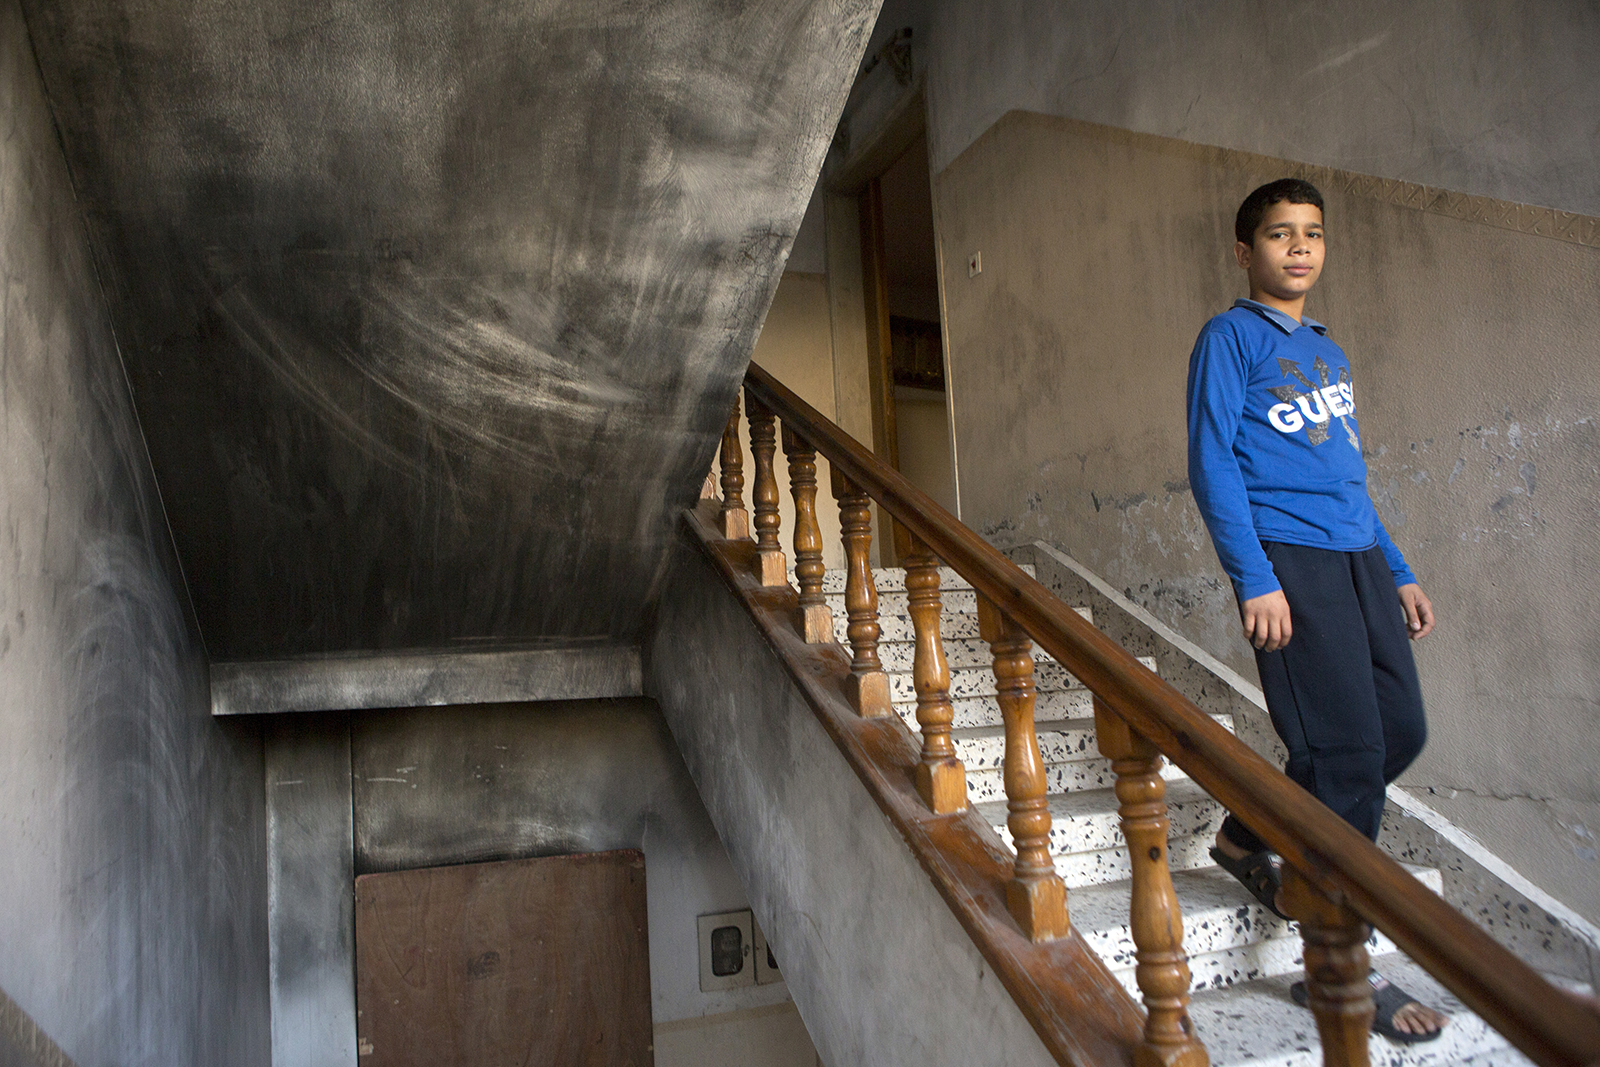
[1283,864,1373,1067]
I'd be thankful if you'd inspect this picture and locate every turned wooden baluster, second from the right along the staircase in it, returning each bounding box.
[1094,697,1211,1067]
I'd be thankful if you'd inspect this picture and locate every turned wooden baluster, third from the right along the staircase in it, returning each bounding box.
[978,597,1070,941]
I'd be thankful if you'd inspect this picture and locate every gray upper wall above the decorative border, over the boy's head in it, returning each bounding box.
[921,0,1600,214]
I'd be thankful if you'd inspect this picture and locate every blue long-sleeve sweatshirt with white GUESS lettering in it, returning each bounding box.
[1187,299,1416,601]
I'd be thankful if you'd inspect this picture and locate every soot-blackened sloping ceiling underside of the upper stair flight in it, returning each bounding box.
[24,0,877,657]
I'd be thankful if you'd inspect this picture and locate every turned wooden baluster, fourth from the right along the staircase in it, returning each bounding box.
[906,536,966,814]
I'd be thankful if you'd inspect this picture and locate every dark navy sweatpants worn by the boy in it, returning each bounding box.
[1222,541,1427,853]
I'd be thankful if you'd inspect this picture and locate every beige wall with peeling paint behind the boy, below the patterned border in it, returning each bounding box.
[934,112,1600,920]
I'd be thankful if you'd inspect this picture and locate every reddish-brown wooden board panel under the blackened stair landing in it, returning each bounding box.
[355,849,654,1067]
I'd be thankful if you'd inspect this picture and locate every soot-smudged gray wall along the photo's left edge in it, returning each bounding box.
[0,0,269,1067]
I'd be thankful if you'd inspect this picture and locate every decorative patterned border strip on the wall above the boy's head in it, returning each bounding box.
[972,109,1600,248]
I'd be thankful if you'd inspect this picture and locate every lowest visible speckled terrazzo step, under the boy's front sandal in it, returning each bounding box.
[1189,952,1566,1067]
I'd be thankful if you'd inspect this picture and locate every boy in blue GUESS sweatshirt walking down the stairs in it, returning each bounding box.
[1187,178,1446,1043]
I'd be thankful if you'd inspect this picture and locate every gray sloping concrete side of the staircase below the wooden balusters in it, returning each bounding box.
[645,544,1054,1067]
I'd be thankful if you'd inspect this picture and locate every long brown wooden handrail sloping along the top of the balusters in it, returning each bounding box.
[746,363,1600,1067]
